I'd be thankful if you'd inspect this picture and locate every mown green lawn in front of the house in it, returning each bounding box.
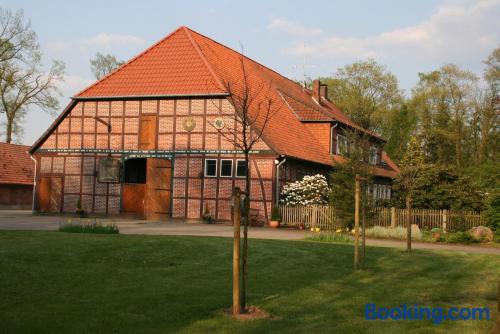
[0,231,500,333]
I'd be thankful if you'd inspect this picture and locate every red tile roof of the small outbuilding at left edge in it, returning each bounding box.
[0,143,35,185]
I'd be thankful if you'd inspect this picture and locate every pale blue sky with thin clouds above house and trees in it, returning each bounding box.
[0,0,500,145]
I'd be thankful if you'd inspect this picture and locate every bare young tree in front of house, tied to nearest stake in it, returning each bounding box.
[206,51,283,311]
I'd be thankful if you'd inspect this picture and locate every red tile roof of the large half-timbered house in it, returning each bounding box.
[31,27,398,176]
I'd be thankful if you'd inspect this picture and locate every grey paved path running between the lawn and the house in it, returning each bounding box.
[0,210,500,255]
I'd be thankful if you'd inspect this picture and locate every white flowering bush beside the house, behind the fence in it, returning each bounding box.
[281,174,329,205]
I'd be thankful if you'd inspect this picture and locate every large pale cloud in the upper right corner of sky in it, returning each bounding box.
[269,0,500,61]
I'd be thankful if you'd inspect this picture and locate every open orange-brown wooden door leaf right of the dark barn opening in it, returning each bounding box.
[145,158,172,220]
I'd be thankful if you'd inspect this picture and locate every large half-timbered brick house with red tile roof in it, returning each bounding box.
[30,27,397,220]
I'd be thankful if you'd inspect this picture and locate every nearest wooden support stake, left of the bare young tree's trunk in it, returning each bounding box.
[233,188,241,316]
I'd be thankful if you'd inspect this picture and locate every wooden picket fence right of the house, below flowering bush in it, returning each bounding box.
[280,205,484,231]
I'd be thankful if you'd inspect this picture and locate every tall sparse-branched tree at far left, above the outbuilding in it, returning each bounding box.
[0,10,64,143]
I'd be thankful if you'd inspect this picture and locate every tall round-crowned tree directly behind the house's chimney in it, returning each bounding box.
[322,59,403,135]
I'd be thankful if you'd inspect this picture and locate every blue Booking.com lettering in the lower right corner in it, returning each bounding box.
[365,304,490,325]
